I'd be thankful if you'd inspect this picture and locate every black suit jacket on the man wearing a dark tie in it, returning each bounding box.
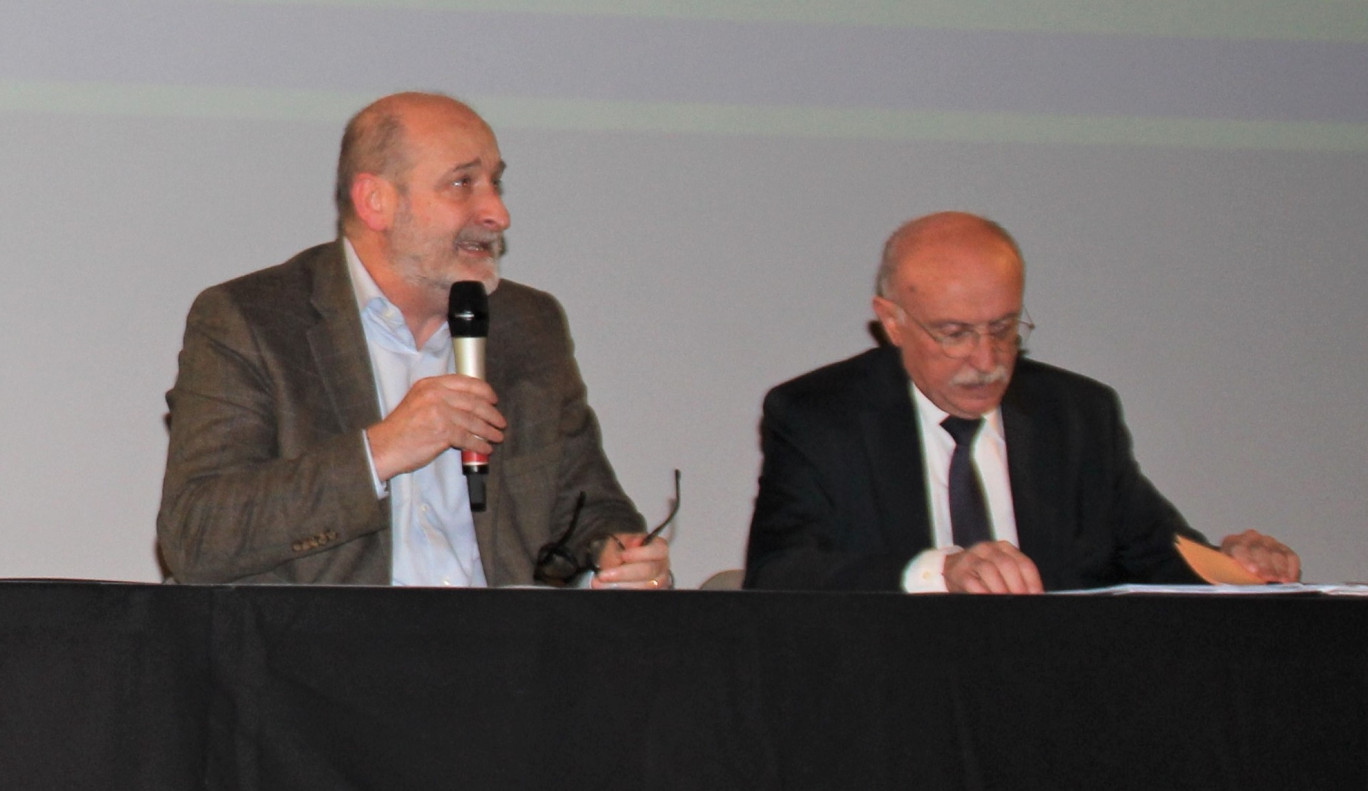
[746,346,1201,590]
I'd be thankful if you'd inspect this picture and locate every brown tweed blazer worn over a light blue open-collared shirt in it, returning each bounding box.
[157,242,643,586]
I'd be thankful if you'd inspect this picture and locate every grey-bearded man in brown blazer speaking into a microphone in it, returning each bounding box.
[157,93,670,590]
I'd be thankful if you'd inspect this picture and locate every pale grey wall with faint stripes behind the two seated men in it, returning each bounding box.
[0,0,1368,584]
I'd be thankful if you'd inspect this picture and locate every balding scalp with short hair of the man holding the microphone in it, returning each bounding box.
[334,92,492,233]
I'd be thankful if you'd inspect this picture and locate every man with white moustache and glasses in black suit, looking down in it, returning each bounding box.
[746,212,1300,594]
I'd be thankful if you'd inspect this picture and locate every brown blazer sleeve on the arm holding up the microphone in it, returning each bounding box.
[157,286,389,584]
